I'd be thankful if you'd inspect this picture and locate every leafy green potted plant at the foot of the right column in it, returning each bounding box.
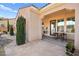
[66,41,75,56]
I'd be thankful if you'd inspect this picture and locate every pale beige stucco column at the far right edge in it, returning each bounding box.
[75,7,79,49]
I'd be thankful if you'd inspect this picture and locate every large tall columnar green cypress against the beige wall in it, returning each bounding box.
[16,16,26,45]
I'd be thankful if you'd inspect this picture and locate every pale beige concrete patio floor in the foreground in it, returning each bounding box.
[5,35,66,56]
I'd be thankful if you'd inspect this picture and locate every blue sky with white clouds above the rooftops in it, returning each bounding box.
[0,3,48,18]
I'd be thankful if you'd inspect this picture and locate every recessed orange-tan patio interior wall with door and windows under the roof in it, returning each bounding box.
[42,8,75,40]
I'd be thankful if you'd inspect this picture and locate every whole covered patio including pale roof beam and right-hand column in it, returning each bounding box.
[40,3,79,50]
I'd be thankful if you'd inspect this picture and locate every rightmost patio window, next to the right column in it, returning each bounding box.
[67,17,75,33]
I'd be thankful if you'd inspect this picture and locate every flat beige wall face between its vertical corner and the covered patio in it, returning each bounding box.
[29,7,42,41]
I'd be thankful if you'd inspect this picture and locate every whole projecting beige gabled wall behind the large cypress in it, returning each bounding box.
[16,6,42,41]
